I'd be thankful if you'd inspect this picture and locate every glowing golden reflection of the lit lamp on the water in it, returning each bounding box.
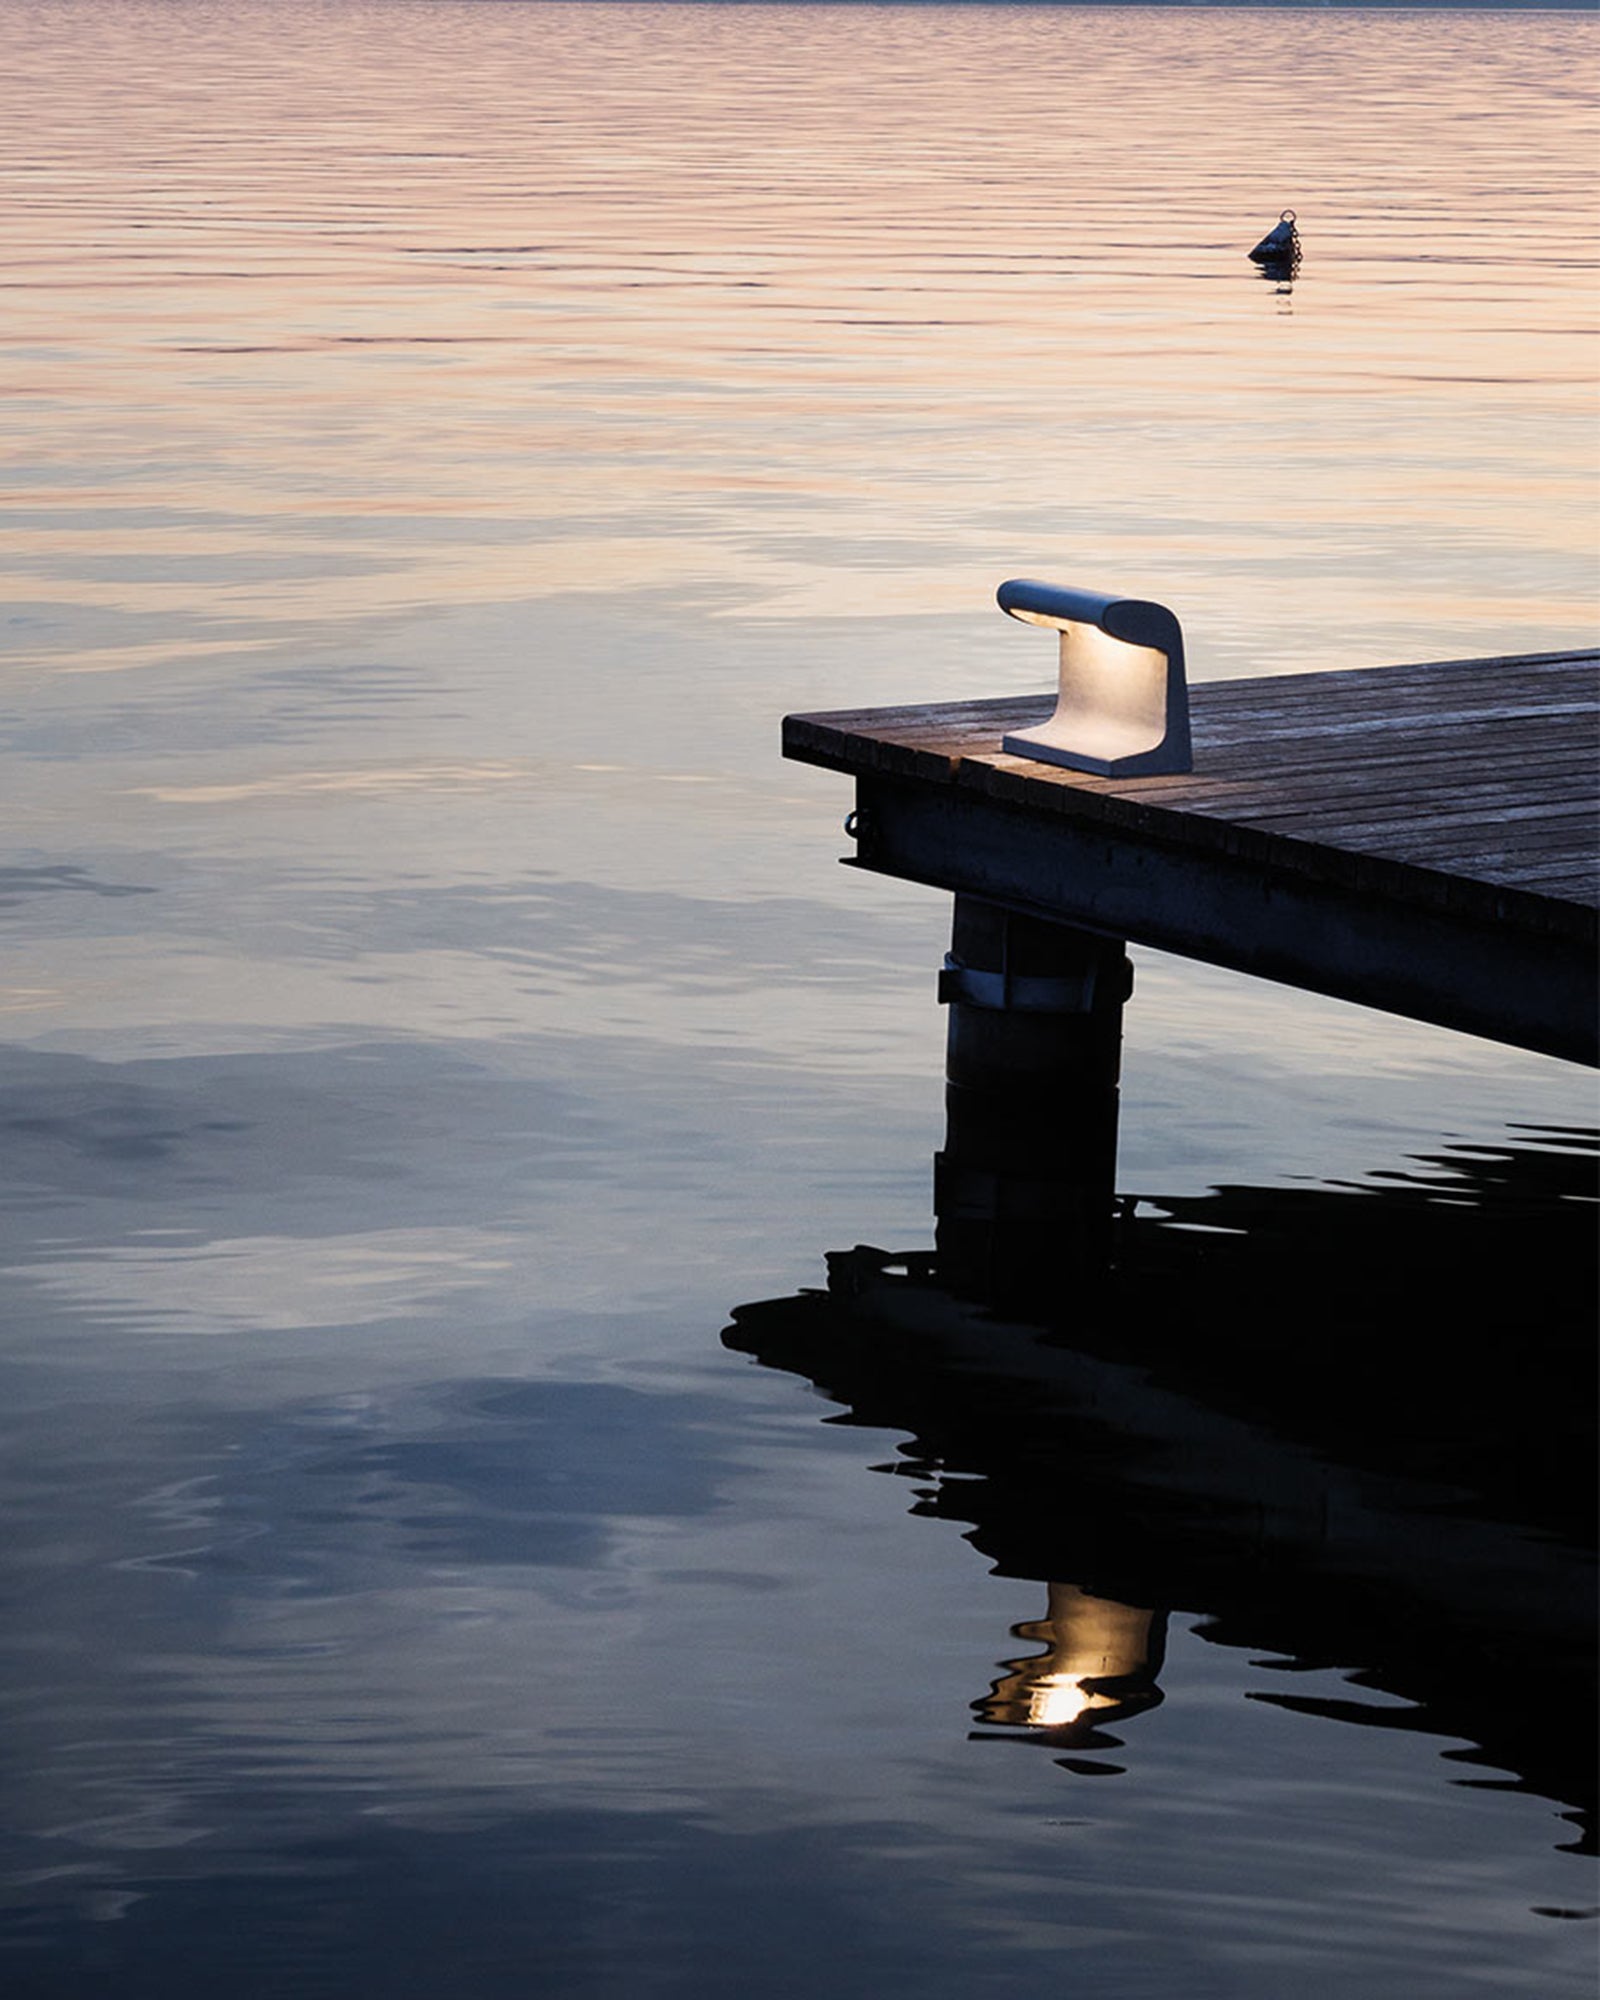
[978,1584,1164,1730]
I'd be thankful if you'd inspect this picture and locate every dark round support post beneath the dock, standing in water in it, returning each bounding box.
[934,896,1132,1310]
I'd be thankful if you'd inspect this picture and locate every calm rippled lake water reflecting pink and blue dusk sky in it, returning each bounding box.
[0,0,1600,2000]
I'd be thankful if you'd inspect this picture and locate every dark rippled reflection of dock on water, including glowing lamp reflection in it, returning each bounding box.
[724,1132,1596,1844]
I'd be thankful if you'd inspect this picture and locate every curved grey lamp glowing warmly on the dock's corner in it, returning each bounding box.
[998,578,1194,778]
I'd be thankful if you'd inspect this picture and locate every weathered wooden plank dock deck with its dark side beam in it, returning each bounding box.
[784,652,1600,1064]
